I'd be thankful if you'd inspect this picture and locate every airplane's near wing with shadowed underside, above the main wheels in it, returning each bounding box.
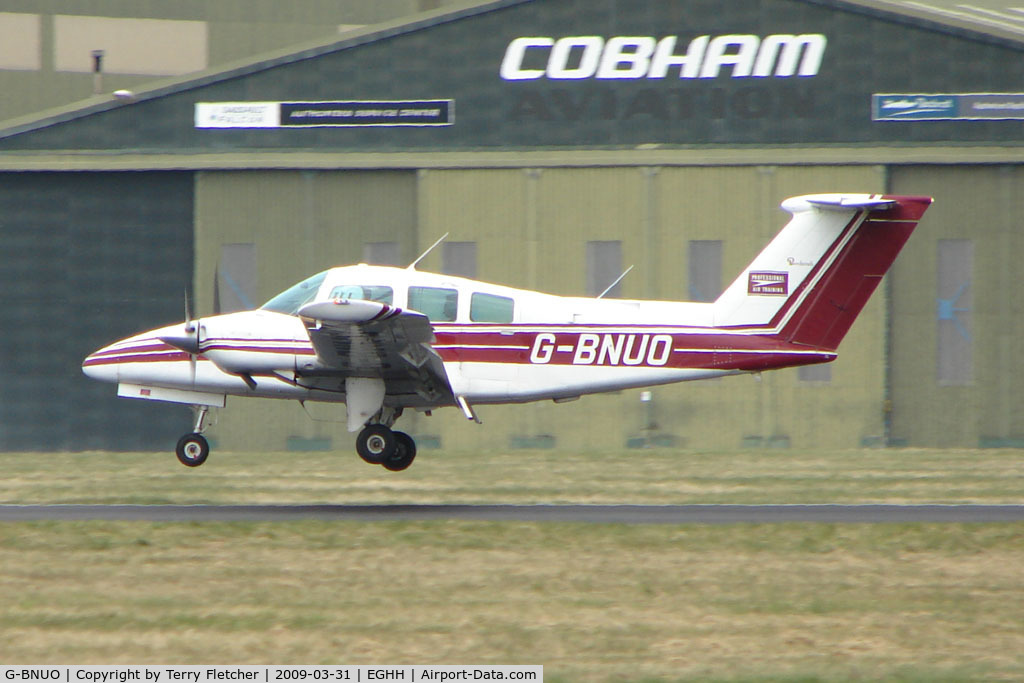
[298,299,455,405]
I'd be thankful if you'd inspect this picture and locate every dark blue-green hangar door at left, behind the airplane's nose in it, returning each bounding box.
[0,173,193,451]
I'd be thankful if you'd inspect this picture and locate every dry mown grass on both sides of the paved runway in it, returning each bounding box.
[0,451,1024,681]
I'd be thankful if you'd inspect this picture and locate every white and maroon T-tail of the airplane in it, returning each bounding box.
[715,195,932,351]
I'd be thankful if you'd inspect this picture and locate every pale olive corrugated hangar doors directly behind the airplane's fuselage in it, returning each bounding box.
[196,166,886,450]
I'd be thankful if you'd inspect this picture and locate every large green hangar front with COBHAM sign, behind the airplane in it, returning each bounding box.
[0,0,1024,450]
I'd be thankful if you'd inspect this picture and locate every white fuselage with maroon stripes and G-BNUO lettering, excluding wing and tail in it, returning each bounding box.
[84,265,835,409]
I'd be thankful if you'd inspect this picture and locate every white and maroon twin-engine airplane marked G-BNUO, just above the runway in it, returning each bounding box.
[83,195,932,471]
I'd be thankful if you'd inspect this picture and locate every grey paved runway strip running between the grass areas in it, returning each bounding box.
[0,505,1024,524]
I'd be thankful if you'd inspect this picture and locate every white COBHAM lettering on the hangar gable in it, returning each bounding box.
[500,33,828,81]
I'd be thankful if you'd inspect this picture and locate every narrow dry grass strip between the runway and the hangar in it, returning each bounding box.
[0,450,1024,504]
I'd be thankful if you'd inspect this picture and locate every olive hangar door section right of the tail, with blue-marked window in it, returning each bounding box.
[891,166,1024,446]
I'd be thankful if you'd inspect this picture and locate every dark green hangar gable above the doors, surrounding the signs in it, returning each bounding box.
[0,0,1024,168]
